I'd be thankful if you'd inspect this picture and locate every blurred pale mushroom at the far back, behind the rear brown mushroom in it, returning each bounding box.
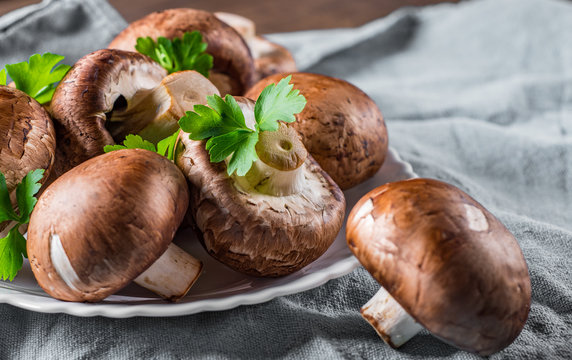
[214,12,298,80]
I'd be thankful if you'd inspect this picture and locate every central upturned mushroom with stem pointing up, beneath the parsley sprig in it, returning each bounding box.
[176,97,345,277]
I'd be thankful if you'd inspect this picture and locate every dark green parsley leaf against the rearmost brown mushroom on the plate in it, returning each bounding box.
[135,31,213,77]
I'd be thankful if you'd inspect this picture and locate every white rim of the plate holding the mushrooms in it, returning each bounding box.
[0,146,418,318]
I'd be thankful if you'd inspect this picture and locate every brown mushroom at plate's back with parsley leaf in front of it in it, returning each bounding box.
[108,9,256,95]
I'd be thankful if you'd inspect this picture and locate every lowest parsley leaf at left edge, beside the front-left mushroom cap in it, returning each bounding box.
[0,224,28,281]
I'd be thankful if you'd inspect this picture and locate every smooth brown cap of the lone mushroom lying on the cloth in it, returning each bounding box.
[346,179,531,355]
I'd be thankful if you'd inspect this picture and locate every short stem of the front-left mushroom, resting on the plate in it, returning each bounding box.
[134,243,203,301]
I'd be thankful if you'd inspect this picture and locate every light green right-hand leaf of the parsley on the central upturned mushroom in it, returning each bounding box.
[254,75,306,131]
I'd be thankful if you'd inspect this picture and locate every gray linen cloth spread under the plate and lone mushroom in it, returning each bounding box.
[0,0,572,359]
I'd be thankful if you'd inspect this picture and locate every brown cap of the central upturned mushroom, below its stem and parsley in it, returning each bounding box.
[177,124,345,277]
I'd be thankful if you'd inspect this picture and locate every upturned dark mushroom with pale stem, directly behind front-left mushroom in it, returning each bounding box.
[51,49,218,175]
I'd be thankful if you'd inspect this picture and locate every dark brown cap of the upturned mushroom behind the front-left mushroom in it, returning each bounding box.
[51,49,167,175]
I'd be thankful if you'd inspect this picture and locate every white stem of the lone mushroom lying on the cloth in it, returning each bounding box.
[361,287,423,348]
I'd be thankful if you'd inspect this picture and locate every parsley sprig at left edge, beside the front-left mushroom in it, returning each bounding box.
[0,169,44,281]
